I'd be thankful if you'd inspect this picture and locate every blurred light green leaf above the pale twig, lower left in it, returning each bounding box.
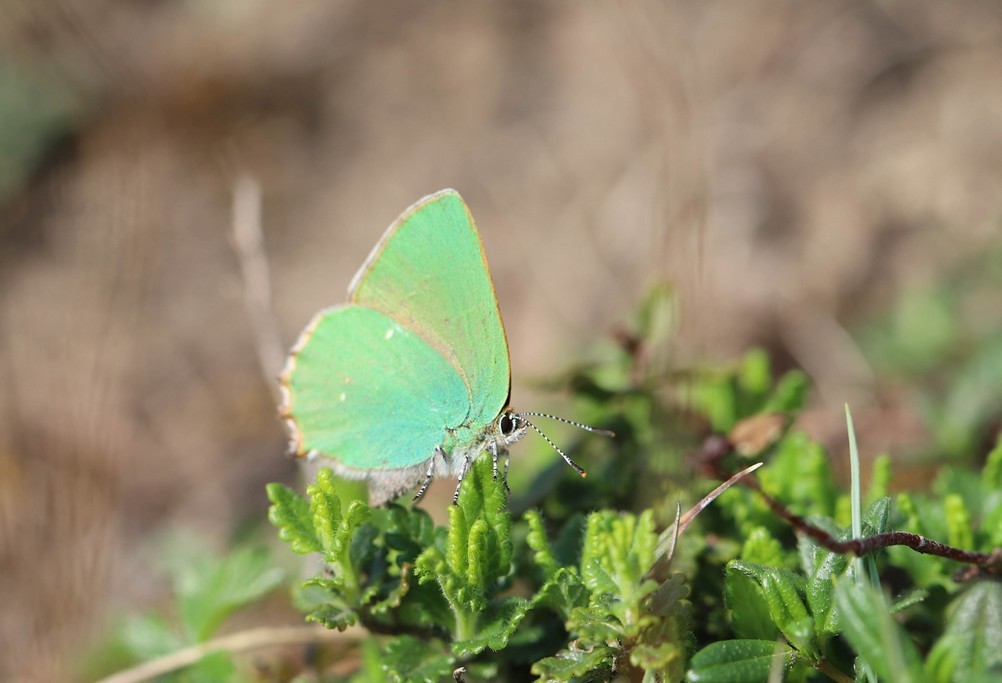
[176,547,283,642]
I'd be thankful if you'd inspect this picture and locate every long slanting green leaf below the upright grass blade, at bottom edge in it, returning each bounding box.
[835,580,924,683]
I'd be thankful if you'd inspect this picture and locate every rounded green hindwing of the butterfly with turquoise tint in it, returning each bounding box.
[283,304,470,471]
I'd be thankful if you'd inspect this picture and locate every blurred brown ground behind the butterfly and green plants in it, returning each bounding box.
[0,0,1002,681]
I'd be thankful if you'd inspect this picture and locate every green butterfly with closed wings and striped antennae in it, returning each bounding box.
[280,189,611,505]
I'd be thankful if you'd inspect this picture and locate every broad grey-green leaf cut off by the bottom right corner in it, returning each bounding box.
[926,581,1002,681]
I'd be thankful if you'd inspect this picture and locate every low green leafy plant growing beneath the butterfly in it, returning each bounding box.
[88,282,1002,683]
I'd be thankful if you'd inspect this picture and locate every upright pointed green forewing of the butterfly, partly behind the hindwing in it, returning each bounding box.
[349,189,511,429]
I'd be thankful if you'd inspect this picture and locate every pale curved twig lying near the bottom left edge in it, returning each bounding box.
[97,626,362,683]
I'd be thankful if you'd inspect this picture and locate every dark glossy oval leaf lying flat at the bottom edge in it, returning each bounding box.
[685,640,797,683]
